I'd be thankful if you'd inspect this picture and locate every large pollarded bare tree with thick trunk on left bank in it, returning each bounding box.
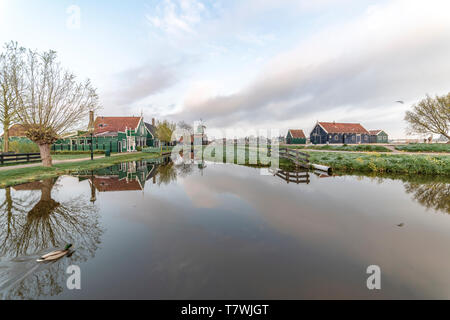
[10,46,100,167]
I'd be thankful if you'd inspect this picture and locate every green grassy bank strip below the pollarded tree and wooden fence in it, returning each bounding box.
[0,153,159,187]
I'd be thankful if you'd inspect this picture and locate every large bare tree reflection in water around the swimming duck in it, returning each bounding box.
[0,179,103,299]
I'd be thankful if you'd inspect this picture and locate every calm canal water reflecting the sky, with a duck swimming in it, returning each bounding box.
[0,161,450,299]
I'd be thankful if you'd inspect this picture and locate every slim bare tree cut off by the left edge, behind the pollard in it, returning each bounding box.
[0,41,25,152]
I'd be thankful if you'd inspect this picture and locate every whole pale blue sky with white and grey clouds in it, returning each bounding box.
[0,0,450,138]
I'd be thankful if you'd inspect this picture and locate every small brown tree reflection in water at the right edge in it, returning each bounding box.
[405,182,450,214]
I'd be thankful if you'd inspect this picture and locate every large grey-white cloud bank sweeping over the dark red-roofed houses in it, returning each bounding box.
[171,0,450,135]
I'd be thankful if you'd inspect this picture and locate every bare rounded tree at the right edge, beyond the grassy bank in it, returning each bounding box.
[405,93,450,139]
